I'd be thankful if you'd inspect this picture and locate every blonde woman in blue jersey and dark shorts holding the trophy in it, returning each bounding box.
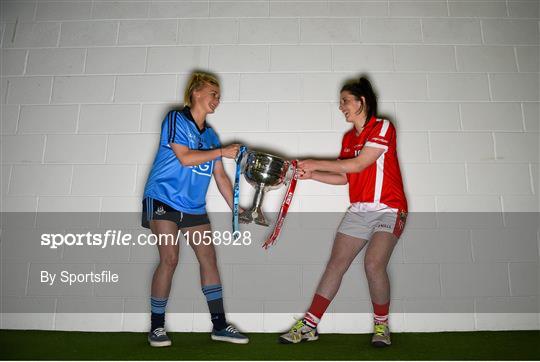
[142,72,249,347]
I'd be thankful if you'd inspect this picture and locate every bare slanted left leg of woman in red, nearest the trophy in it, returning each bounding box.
[316,232,367,300]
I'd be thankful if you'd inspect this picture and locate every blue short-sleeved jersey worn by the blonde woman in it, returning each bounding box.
[144,107,221,214]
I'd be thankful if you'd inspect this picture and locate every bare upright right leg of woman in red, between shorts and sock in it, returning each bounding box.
[364,231,398,304]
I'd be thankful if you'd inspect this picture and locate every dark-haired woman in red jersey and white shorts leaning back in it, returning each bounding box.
[280,77,407,347]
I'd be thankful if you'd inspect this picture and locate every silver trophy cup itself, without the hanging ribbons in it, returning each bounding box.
[238,151,294,226]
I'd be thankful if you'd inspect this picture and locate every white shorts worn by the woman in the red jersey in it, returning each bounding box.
[337,203,407,240]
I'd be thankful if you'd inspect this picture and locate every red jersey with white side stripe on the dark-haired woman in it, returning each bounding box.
[339,117,407,211]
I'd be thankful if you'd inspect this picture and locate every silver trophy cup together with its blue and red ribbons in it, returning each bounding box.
[233,146,298,249]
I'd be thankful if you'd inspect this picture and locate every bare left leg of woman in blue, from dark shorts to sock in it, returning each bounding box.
[150,220,180,298]
